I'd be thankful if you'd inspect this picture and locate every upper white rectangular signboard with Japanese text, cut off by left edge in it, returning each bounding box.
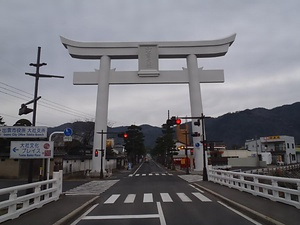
[0,126,47,138]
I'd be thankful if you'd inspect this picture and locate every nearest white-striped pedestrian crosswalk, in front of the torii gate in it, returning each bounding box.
[103,192,211,204]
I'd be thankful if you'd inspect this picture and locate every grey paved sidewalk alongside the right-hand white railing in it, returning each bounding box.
[195,181,300,225]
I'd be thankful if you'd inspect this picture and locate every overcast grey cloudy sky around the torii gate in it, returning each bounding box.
[0,0,300,126]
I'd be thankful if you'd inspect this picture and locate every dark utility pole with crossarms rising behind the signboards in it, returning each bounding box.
[25,47,64,183]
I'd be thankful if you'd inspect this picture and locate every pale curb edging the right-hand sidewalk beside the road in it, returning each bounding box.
[193,183,284,225]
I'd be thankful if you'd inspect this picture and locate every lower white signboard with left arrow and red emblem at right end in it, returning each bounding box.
[10,141,54,159]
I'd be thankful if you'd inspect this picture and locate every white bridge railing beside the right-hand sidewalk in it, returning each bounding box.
[208,169,300,209]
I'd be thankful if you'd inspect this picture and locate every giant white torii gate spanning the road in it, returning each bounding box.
[61,34,236,172]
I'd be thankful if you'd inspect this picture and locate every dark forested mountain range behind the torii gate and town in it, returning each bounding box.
[48,102,300,149]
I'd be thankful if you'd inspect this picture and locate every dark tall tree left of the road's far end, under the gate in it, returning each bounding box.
[124,125,146,164]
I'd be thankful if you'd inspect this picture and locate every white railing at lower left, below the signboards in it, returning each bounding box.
[0,171,62,223]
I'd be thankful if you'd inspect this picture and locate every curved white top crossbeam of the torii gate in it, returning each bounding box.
[61,34,236,59]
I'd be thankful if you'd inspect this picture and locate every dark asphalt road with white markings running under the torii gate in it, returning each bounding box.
[72,160,259,225]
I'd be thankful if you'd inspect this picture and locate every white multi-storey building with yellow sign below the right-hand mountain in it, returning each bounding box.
[245,135,297,165]
